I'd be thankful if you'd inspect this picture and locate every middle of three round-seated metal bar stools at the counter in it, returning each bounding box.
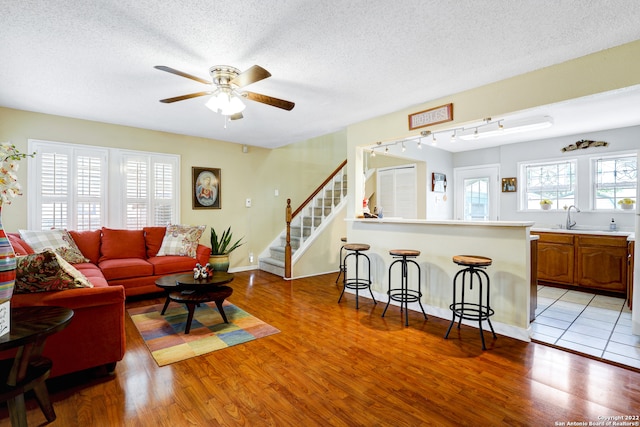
[382,249,427,326]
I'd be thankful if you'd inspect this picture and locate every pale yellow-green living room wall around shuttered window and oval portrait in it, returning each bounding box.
[0,108,346,269]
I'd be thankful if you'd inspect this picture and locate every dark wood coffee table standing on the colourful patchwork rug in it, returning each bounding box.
[156,271,233,334]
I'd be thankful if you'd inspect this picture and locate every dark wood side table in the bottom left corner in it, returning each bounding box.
[0,306,73,427]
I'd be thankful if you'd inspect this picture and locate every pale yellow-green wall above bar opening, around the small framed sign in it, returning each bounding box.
[347,40,640,218]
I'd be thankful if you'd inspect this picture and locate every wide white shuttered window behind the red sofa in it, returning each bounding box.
[28,140,180,230]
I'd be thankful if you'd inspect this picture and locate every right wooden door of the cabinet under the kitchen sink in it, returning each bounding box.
[575,235,628,294]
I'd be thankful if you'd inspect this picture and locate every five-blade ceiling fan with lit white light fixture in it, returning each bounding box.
[154,65,296,120]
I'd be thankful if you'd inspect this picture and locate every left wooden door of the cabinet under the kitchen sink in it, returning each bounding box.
[535,233,575,285]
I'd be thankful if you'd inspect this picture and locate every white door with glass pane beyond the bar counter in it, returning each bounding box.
[454,165,500,221]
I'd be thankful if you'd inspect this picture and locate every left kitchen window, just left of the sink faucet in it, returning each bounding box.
[520,160,577,210]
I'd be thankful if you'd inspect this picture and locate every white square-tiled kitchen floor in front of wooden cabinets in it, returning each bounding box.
[531,286,640,369]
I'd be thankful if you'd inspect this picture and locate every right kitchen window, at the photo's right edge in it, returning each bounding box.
[592,155,638,210]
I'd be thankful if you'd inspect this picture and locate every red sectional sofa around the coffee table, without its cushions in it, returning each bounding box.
[5,227,210,377]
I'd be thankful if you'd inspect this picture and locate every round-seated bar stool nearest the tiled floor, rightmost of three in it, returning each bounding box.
[444,255,497,350]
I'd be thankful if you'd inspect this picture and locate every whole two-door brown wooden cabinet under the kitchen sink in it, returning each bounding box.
[534,232,632,296]
